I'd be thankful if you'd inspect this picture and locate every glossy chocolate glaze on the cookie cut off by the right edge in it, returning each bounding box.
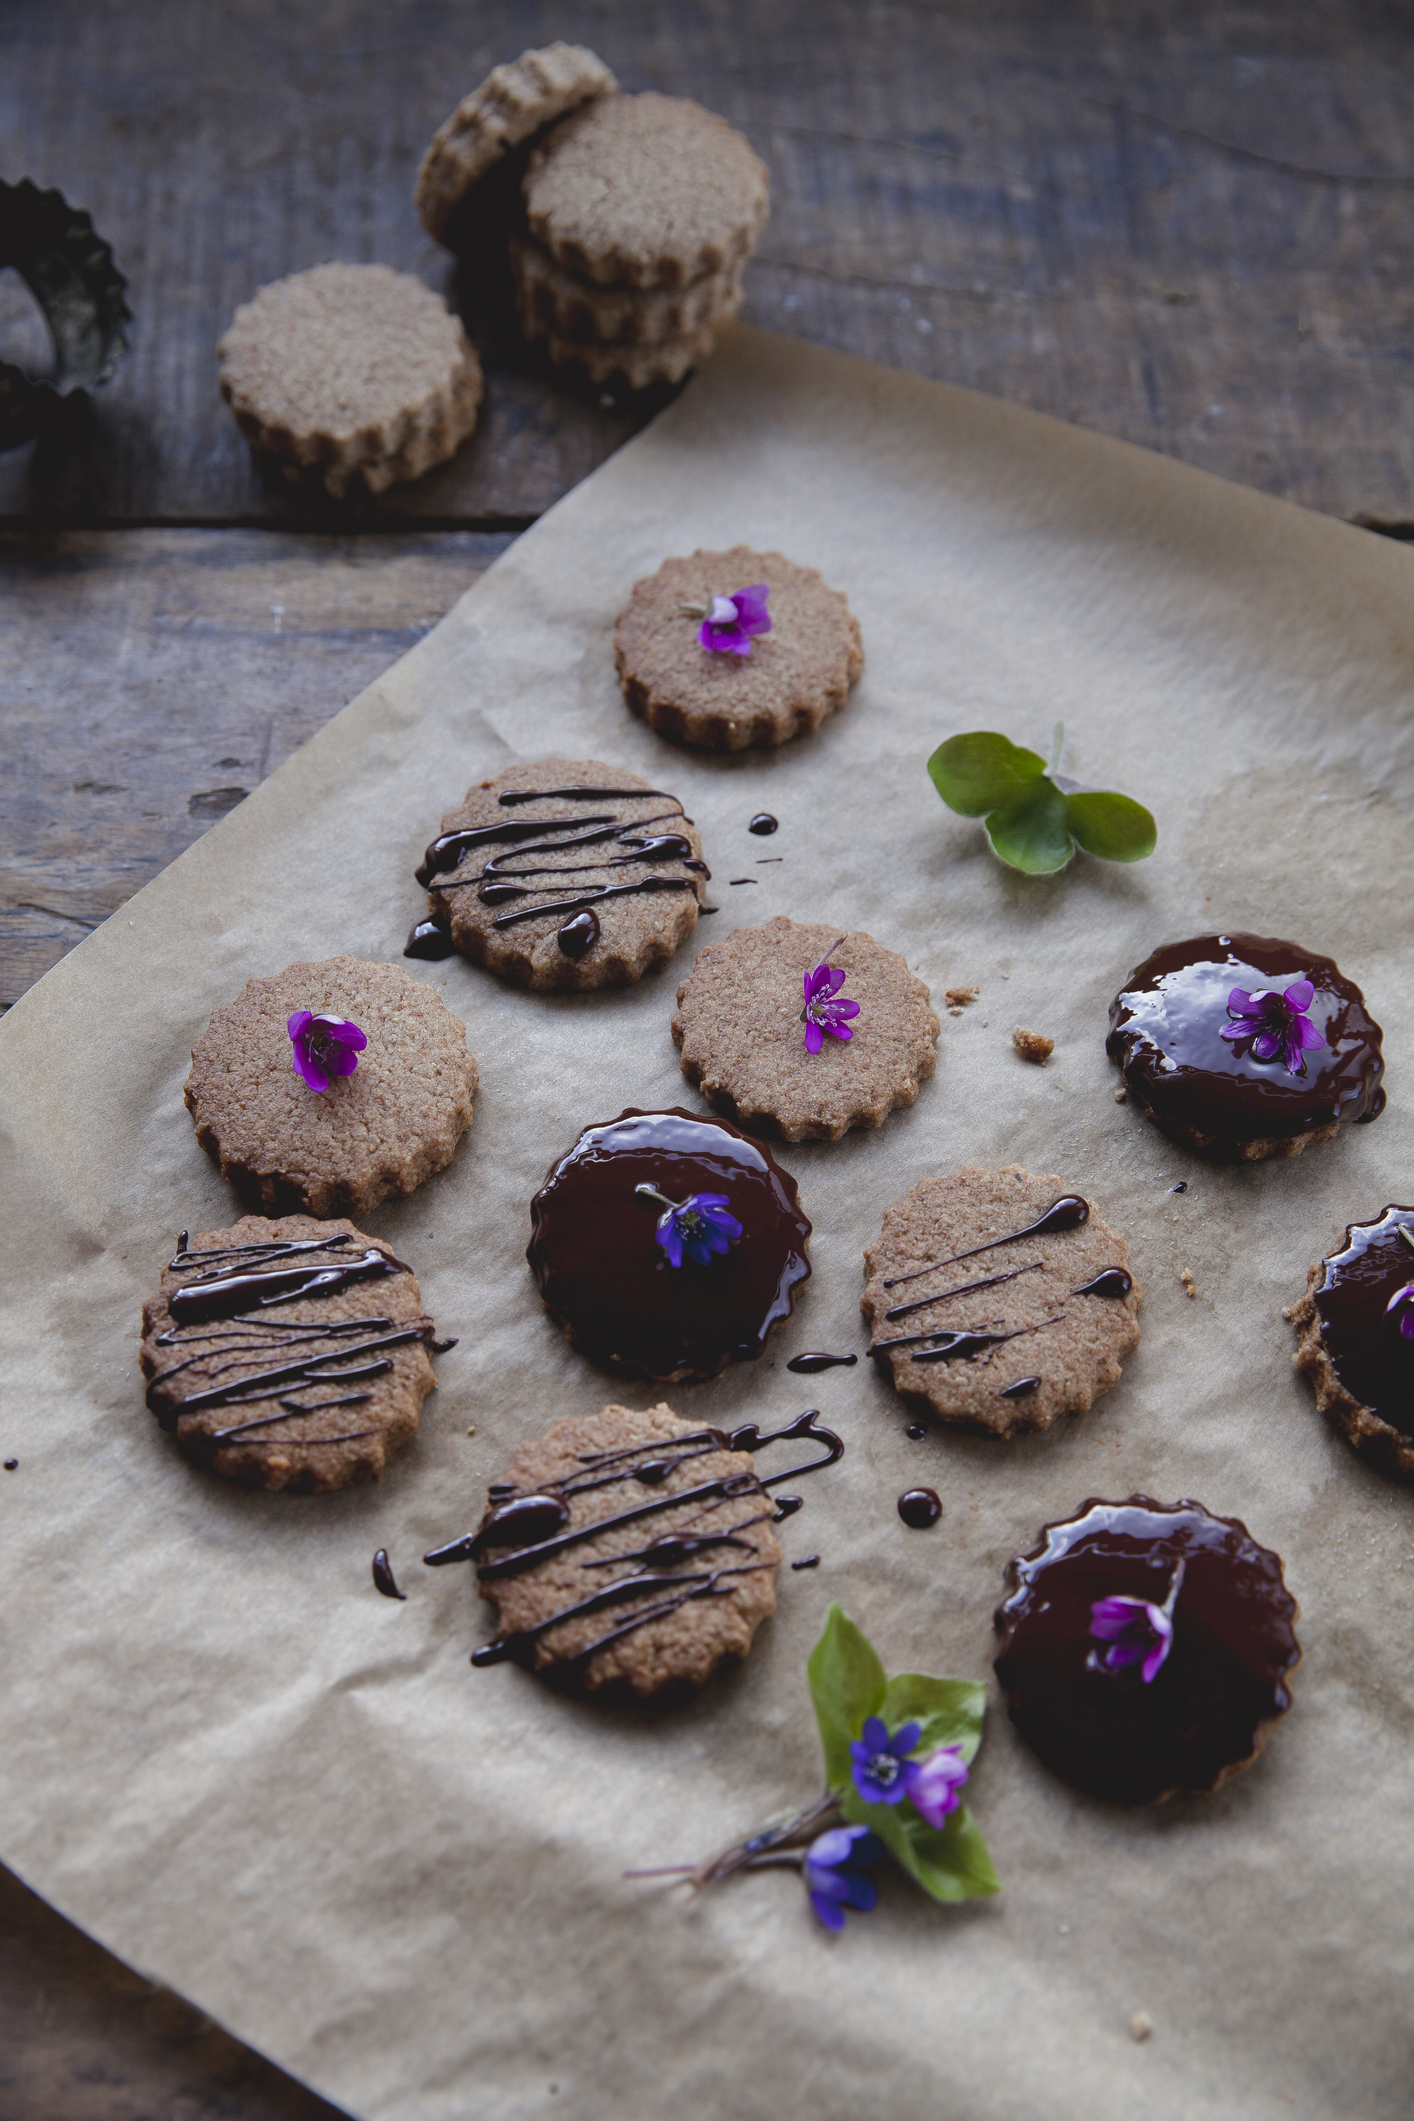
[1312,1207,1414,1436]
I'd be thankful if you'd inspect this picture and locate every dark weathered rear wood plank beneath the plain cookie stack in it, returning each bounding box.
[0,0,1414,526]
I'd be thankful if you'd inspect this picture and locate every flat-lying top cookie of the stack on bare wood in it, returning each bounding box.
[522,91,772,286]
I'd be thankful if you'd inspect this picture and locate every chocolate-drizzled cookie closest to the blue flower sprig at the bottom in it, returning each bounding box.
[460,1406,780,1699]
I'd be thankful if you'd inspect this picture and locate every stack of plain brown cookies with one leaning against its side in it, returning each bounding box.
[413,45,770,390]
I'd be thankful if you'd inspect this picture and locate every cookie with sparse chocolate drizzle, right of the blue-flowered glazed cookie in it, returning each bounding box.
[861,1164,1143,1436]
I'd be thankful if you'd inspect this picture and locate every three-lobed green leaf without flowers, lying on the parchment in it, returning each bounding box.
[929,721,1157,876]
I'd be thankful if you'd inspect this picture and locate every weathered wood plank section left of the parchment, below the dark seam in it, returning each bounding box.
[0,530,511,1007]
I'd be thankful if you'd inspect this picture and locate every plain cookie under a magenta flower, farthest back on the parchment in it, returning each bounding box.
[615,545,865,751]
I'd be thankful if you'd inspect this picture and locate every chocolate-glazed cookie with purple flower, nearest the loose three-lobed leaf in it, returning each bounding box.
[1104,933,1384,1164]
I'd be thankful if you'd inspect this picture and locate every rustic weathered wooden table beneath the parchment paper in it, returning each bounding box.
[0,0,1414,2121]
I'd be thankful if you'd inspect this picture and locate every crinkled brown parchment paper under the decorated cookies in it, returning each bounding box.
[0,331,1414,2121]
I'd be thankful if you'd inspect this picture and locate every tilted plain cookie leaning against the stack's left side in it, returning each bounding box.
[413,45,619,242]
